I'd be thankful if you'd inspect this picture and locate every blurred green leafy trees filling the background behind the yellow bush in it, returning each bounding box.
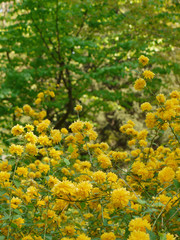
[0,0,180,148]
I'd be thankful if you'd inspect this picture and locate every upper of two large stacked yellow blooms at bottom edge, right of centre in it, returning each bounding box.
[129,218,151,232]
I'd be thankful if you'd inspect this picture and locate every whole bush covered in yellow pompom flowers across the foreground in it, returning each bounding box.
[0,56,180,240]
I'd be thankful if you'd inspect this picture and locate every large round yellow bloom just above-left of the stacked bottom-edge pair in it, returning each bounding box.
[111,188,130,208]
